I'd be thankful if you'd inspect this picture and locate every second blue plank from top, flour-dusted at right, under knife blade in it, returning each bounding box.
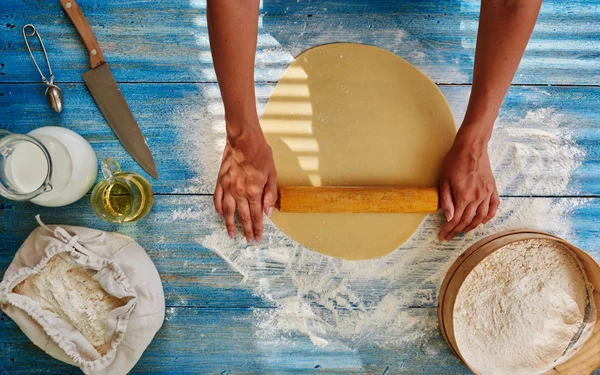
[0,83,600,196]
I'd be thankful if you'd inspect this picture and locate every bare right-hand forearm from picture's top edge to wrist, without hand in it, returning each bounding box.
[459,0,542,144]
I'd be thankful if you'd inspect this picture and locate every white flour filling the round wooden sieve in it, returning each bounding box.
[454,239,595,375]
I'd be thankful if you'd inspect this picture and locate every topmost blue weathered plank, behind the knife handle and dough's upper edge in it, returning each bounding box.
[0,0,600,85]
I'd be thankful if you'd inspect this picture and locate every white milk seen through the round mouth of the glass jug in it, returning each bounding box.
[10,142,48,194]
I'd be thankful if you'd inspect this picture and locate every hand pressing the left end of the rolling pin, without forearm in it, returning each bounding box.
[214,126,277,243]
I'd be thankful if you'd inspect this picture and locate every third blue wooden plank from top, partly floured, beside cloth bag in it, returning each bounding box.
[0,196,600,309]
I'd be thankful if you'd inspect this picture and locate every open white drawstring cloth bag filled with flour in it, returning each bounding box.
[0,217,165,375]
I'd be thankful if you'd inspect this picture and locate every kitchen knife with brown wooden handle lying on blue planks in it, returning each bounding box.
[60,0,158,178]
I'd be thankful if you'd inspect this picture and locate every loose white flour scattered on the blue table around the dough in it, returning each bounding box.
[182,4,583,354]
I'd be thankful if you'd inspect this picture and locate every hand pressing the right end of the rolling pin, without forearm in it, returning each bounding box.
[440,127,500,240]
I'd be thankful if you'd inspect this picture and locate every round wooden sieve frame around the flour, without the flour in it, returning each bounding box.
[438,230,600,375]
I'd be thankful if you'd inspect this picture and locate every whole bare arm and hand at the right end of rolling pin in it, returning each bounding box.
[440,0,542,240]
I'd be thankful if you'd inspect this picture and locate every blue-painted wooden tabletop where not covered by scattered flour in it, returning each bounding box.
[0,0,600,374]
